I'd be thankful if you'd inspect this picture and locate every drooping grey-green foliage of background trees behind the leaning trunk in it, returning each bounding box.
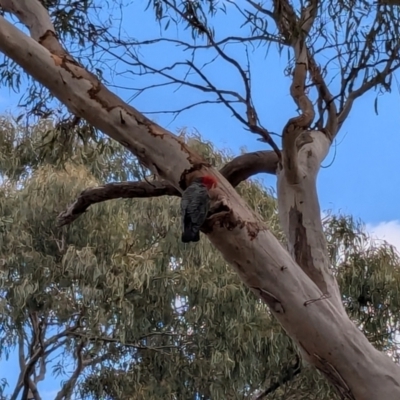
[0,117,400,400]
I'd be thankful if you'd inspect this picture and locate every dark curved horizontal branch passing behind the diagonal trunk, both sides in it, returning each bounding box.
[58,151,279,226]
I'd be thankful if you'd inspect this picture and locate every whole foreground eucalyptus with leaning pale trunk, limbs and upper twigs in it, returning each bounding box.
[0,0,400,399]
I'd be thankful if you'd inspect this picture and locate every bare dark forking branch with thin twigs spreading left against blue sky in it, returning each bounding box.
[101,0,281,158]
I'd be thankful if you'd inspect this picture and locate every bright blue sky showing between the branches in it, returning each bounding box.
[0,1,400,400]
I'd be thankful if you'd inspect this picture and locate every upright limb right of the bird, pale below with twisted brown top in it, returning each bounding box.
[266,0,342,308]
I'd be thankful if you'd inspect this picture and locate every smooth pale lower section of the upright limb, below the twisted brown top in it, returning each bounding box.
[277,131,342,308]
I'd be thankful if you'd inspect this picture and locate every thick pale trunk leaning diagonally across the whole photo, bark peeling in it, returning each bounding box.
[0,0,400,400]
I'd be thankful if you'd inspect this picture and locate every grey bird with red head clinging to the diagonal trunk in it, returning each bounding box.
[181,175,217,243]
